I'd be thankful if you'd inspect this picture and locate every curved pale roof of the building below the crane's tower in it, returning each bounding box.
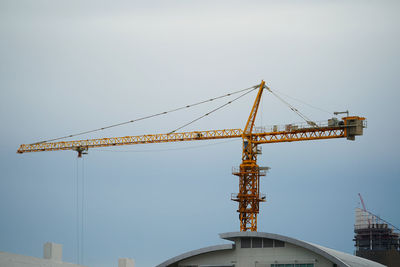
[156,232,385,267]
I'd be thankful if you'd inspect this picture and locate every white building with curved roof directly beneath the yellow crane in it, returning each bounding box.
[157,232,384,267]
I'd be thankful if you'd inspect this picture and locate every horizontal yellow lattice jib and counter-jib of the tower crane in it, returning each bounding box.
[17,116,365,153]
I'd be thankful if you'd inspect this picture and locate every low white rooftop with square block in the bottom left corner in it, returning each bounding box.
[0,243,84,267]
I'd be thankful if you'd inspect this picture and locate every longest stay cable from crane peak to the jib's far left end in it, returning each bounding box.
[32,85,259,145]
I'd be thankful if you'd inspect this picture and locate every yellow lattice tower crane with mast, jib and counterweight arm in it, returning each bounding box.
[17,81,365,231]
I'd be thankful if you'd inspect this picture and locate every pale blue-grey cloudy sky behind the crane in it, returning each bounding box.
[0,0,400,267]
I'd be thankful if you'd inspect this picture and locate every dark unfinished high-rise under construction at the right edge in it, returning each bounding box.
[354,208,400,267]
